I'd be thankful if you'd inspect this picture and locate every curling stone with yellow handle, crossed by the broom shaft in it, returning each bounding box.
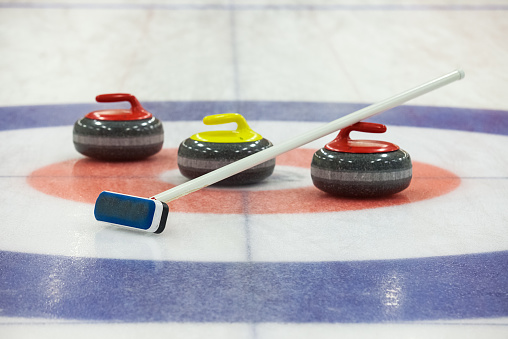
[178,113,275,185]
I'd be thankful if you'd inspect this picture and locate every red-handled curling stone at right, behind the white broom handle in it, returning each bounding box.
[311,122,412,198]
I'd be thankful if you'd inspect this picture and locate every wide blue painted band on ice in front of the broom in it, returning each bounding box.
[0,251,508,323]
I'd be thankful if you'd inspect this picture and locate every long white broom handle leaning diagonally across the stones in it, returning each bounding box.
[153,70,464,202]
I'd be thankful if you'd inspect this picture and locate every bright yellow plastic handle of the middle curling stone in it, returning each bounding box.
[191,113,263,143]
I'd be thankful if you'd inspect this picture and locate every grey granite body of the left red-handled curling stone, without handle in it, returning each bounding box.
[73,117,164,161]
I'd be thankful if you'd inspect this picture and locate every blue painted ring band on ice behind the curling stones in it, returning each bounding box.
[0,101,508,135]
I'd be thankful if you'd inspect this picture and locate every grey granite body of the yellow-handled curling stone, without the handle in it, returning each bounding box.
[178,138,275,185]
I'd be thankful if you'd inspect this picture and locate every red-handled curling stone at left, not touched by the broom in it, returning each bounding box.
[73,93,164,161]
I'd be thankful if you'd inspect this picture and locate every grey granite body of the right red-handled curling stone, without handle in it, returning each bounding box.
[311,148,412,198]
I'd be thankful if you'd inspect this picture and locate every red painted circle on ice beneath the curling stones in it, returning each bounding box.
[27,148,460,214]
